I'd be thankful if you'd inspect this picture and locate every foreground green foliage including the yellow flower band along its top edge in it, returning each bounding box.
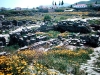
[38,50,93,75]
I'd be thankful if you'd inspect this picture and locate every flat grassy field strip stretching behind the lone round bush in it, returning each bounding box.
[6,12,87,21]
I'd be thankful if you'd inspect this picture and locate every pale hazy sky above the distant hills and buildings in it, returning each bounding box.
[0,0,89,8]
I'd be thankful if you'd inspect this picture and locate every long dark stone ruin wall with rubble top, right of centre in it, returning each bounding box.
[54,20,92,33]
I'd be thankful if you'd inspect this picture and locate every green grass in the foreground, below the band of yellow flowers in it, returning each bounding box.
[38,49,93,75]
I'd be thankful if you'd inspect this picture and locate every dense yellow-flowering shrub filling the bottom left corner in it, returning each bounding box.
[0,55,27,75]
